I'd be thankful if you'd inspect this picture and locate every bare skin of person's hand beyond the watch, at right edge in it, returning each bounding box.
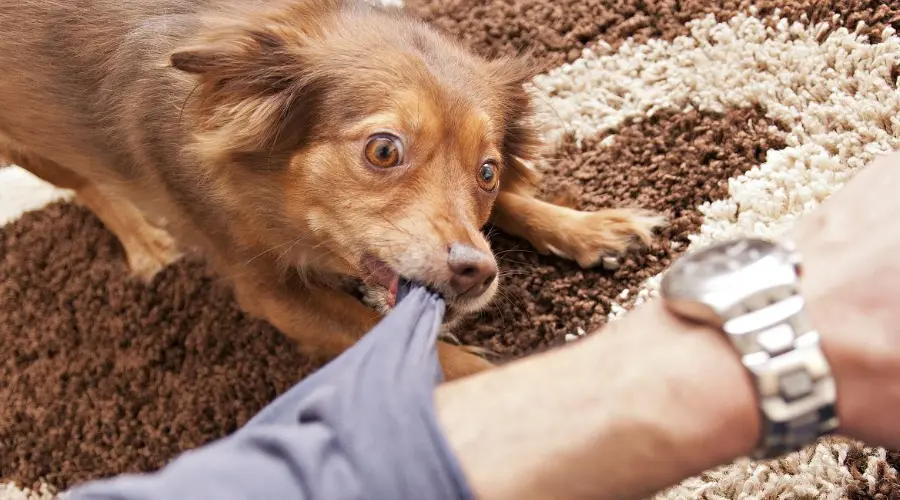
[791,153,900,447]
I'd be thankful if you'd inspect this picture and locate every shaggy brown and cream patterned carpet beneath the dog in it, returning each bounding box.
[0,0,900,500]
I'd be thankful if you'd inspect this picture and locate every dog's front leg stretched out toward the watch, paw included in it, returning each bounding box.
[493,191,665,268]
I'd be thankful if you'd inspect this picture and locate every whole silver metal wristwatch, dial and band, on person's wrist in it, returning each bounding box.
[661,238,838,459]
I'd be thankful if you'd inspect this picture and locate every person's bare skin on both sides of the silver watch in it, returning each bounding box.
[436,154,900,500]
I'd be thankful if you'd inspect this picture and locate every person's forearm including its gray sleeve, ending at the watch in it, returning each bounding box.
[63,296,756,500]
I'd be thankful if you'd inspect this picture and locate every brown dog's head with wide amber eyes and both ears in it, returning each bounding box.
[171,0,539,312]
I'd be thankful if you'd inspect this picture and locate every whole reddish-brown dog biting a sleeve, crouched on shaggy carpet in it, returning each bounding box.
[0,0,662,379]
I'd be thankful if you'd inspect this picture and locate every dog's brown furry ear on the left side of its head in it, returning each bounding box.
[169,18,323,166]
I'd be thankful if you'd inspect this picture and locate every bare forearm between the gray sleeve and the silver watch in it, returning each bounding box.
[437,301,759,500]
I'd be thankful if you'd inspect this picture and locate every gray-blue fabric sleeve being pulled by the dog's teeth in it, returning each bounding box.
[65,288,473,500]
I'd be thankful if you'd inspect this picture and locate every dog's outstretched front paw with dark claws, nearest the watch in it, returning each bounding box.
[539,208,666,268]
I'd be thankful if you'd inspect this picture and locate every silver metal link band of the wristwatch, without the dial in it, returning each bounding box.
[723,294,838,460]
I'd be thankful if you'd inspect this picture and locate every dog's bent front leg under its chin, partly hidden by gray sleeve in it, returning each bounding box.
[235,280,493,380]
